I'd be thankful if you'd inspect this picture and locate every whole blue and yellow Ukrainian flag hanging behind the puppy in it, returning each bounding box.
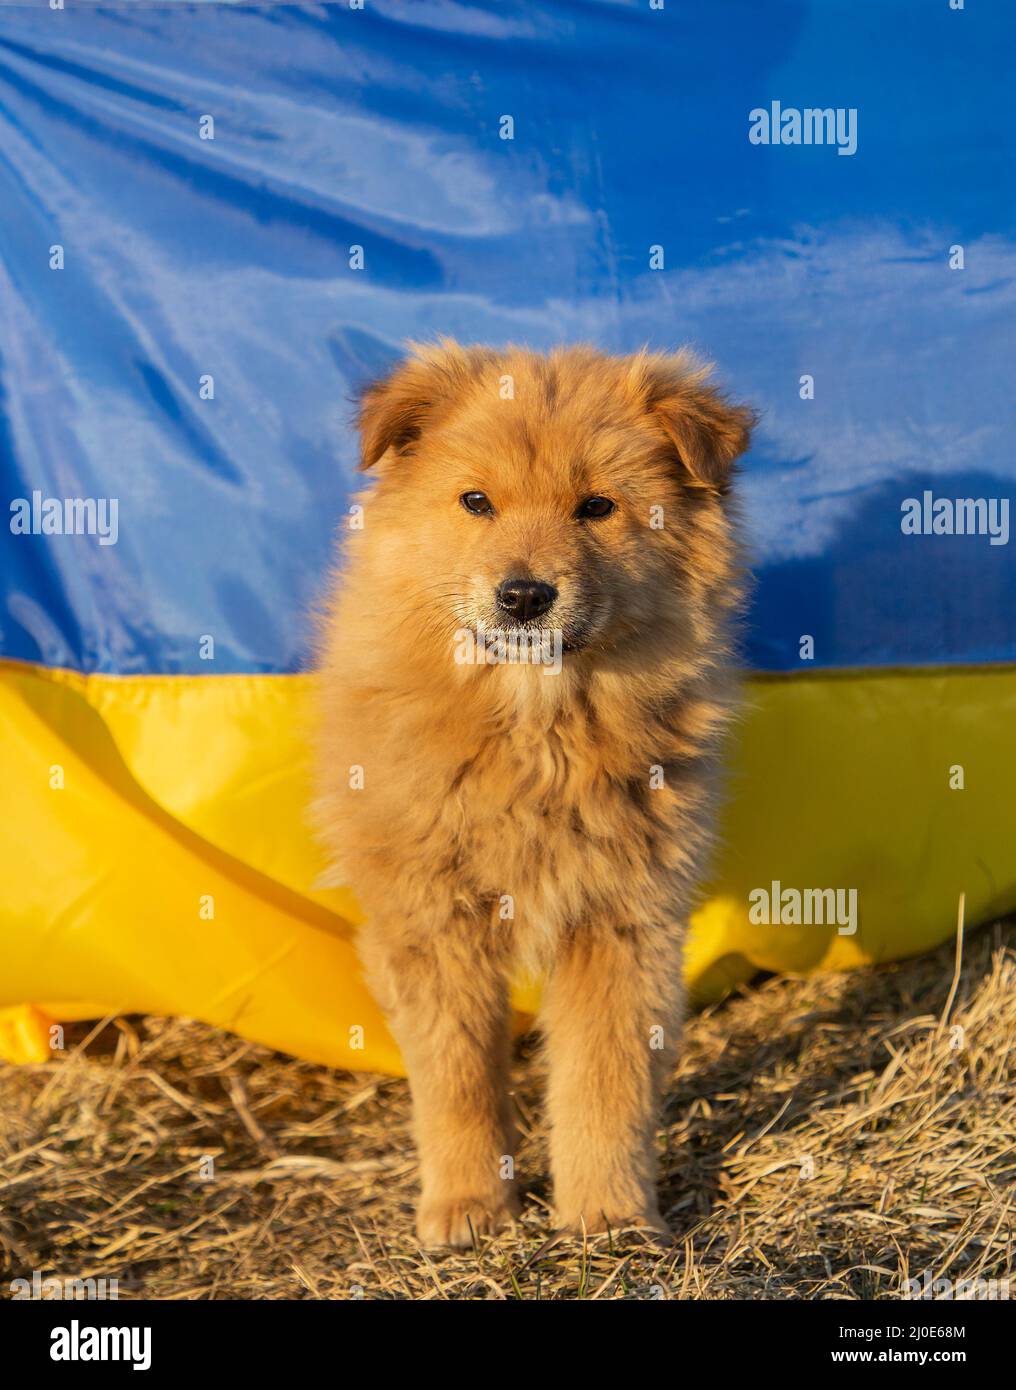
[0,0,1016,1070]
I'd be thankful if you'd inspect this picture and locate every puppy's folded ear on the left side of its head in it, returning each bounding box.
[357,338,492,468]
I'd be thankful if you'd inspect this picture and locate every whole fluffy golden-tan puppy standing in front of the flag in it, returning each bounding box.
[317,341,752,1245]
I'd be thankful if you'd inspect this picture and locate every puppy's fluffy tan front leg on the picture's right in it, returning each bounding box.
[543,926,681,1232]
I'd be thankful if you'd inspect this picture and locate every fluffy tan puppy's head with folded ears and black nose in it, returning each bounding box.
[359,341,752,659]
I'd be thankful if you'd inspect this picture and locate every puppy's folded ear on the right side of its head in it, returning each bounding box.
[632,352,757,495]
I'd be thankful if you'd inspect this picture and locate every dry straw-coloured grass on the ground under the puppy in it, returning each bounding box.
[0,923,1016,1298]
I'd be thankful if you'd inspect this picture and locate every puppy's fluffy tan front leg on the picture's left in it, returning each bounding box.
[360,916,517,1247]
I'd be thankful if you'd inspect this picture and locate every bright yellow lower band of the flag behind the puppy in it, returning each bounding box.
[0,663,1016,1072]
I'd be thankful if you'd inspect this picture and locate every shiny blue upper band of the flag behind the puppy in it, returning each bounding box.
[0,0,1016,673]
